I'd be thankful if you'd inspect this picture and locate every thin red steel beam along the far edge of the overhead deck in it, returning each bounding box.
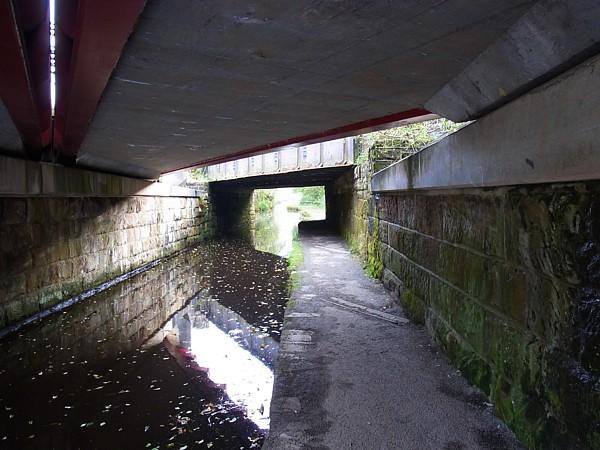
[163,108,431,174]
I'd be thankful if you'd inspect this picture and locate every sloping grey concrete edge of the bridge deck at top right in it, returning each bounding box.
[425,0,600,122]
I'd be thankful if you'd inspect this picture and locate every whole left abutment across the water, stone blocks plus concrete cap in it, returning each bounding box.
[0,157,214,328]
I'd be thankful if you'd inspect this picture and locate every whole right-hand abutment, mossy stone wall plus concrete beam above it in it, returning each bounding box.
[332,54,600,448]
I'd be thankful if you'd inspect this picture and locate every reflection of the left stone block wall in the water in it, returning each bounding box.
[0,246,208,376]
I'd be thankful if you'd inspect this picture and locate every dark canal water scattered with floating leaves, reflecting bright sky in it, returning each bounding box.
[0,242,288,449]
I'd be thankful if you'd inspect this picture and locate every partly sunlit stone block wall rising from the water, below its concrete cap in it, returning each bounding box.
[0,196,214,327]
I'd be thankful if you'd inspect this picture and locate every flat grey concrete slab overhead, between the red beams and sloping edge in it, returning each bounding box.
[78,0,531,178]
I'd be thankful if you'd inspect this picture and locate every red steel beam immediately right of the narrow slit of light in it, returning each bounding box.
[54,0,146,157]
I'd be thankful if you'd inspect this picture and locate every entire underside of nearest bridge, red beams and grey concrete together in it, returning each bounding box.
[8,0,600,178]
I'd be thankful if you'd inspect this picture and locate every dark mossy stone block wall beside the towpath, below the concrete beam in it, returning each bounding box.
[378,182,600,449]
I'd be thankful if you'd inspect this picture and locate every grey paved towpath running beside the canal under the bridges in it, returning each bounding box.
[263,233,522,450]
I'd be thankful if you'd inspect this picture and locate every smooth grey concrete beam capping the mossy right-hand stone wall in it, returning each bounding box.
[371,52,600,193]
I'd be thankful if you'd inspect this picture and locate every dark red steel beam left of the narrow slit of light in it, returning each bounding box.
[0,0,51,152]
